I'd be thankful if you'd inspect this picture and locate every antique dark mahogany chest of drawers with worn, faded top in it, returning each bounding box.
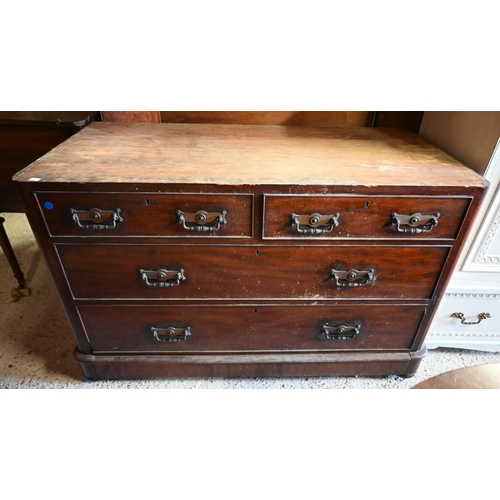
[15,123,487,379]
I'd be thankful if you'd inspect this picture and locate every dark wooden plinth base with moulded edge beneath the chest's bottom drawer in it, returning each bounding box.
[75,348,426,379]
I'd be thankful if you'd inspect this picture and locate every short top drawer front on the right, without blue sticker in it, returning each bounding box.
[263,195,470,240]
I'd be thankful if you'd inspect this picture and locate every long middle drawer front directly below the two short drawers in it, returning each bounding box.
[56,244,449,299]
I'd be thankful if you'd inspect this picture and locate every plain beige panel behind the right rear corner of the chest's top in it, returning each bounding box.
[419,111,500,175]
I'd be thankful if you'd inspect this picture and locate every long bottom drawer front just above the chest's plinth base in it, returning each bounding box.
[78,305,425,353]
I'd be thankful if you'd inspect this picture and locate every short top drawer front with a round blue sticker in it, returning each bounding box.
[36,191,253,239]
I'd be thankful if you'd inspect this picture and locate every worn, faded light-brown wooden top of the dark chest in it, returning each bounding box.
[14,122,487,187]
